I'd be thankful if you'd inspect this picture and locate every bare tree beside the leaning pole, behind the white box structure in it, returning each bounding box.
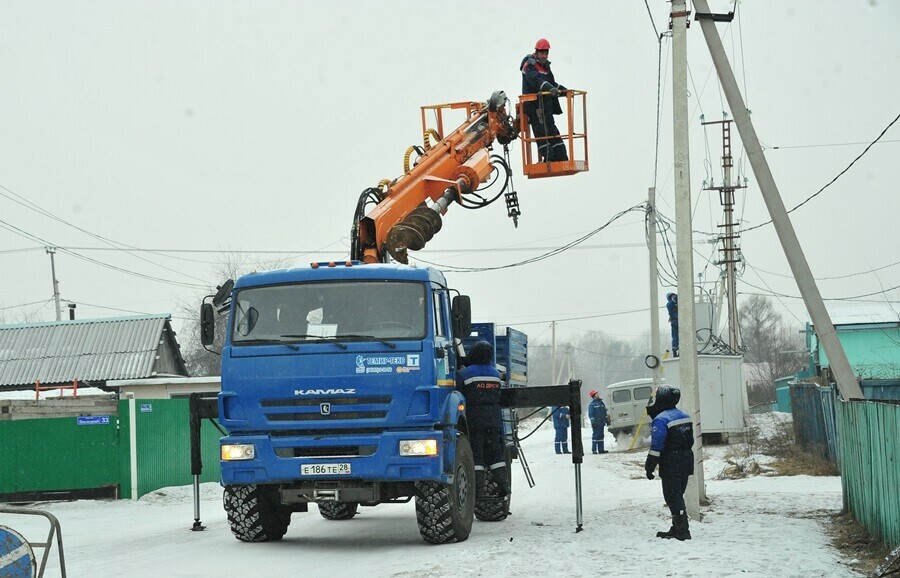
[738,295,807,405]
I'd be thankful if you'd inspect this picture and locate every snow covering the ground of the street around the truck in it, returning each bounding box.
[0,414,858,578]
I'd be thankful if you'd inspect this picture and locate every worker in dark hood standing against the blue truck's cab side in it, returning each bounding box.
[456,341,509,498]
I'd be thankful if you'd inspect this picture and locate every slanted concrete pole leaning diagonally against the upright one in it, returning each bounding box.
[688,0,863,399]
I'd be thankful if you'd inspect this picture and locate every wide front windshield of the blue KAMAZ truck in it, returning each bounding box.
[231,281,427,345]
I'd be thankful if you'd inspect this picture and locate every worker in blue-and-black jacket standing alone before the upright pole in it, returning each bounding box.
[644,385,694,541]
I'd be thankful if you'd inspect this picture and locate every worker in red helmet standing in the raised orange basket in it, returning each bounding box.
[519,38,569,162]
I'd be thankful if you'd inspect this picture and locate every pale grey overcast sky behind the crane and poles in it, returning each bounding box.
[0,0,900,341]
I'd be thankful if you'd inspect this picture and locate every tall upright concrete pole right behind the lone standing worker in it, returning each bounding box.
[671,0,706,520]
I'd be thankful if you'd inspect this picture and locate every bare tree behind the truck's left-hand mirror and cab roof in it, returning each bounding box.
[178,253,292,376]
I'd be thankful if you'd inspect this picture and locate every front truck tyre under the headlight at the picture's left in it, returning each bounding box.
[223,484,291,542]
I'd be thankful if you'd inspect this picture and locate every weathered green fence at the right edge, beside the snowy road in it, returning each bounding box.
[835,401,900,547]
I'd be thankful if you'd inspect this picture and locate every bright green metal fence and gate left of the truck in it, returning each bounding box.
[0,399,221,498]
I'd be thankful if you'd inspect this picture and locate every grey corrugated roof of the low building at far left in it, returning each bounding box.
[0,315,170,386]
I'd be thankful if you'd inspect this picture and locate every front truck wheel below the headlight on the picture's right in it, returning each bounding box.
[416,434,475,544]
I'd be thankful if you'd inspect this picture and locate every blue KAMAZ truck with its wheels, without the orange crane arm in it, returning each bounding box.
[202,261,527,544]
